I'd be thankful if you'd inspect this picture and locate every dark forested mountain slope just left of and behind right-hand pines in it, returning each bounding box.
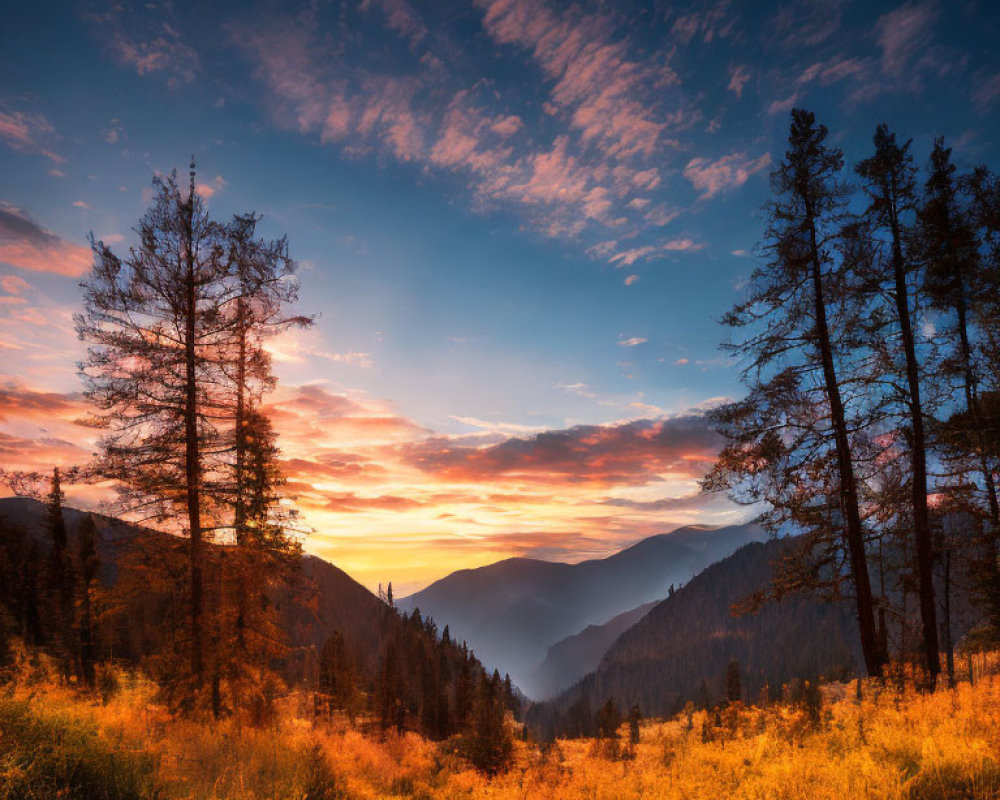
[529,539,859,736]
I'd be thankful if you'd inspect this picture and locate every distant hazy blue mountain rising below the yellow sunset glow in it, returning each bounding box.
[399,525,765,697]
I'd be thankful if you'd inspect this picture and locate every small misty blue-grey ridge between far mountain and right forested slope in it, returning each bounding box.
[531,601,658,700]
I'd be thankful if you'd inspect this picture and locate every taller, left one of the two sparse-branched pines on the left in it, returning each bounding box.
[76,163,226,697]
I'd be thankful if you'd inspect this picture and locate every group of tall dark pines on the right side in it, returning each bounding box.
[705,109,1000,688]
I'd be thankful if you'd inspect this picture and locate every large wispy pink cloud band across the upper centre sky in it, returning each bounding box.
[231,0,712,260]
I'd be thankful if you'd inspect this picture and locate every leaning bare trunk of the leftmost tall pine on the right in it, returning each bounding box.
[800,197,885,676]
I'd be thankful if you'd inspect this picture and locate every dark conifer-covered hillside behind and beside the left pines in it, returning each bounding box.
[0,495,522,772]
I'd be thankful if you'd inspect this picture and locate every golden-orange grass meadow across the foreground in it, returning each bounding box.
[0,664,1000,800]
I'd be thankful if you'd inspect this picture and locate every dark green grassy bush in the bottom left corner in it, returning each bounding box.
[0,700,157,800]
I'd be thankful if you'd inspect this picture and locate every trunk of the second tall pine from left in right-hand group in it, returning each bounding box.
[885,202,941,689]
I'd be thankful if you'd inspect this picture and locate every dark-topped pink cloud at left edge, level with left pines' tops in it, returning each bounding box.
[0,202,91,277]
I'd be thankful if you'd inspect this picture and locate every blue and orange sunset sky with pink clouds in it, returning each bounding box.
[0,0,1000,595]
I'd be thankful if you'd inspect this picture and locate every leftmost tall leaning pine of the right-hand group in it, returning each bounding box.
[704,108,885,675]
